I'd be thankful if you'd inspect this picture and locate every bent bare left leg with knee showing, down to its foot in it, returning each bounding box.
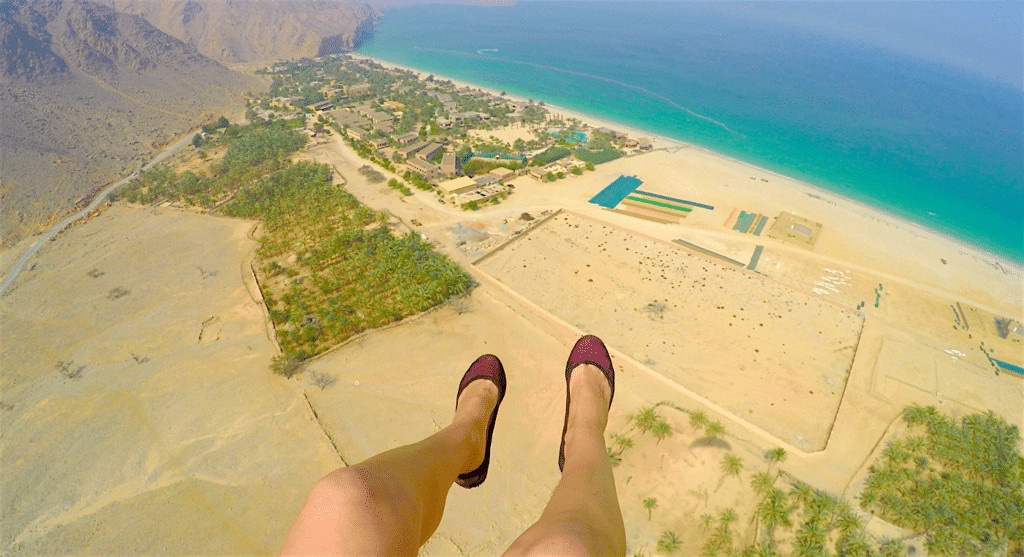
[281,356,504,555]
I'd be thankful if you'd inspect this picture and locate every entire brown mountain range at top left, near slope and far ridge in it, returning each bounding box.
[0,0,373,247]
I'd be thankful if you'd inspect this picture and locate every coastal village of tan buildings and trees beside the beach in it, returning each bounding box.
[250,56,652,210]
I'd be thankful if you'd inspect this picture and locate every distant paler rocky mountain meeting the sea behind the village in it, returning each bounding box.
[106,0,373,68]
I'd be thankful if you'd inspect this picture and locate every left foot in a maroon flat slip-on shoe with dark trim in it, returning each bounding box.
[452,354,506,488]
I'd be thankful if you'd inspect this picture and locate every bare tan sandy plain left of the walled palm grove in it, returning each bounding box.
[0,207,340,555]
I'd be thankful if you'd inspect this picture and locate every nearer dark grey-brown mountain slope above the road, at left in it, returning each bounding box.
[0,0,251,245]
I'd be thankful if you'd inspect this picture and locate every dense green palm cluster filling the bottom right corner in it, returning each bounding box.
[860,405,1024,555]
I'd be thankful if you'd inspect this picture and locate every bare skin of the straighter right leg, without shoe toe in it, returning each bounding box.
[505,365,626,555]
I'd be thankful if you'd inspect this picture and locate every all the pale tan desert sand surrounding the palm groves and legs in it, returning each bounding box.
[0,75,1024,555]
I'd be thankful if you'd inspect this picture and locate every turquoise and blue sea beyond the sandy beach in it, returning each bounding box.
[357,1,1024,263]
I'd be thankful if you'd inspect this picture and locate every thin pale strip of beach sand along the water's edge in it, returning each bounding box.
[349,51,1024,277]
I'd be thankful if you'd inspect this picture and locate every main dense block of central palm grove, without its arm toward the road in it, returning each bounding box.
[223,163,471,360]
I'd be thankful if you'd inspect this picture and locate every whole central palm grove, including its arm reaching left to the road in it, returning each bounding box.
[117,122,472,370]
